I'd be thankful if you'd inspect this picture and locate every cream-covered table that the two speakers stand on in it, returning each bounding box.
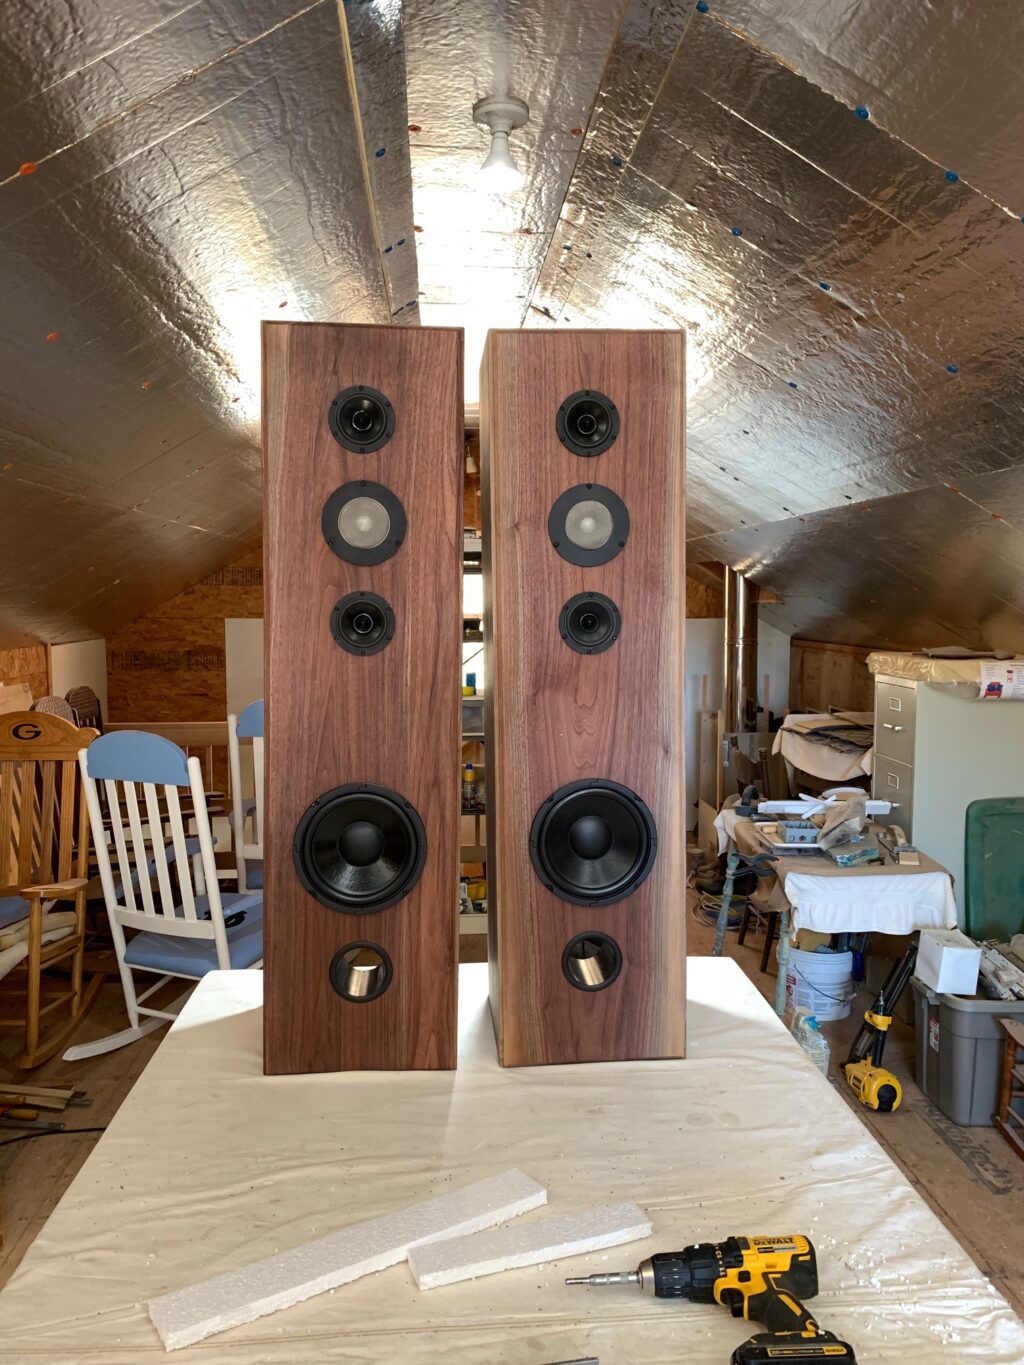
[0,958,1024,1365]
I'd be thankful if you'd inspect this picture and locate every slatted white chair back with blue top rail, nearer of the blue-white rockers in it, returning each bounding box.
[79,730,231,968]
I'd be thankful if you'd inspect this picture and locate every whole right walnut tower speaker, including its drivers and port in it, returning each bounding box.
[481,330,685,1066]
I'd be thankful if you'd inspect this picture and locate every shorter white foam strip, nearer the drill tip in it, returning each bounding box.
[408,1204,651,1289]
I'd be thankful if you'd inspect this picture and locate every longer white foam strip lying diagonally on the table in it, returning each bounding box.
[146,1170,547,1351]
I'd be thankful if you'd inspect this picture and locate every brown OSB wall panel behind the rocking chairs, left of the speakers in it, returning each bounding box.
[106,549,264,722]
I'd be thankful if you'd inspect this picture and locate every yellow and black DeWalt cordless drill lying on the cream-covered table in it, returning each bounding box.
[565,1237,856,1365]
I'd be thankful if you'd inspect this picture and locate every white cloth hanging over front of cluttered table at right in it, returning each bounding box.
[781,870,957,934]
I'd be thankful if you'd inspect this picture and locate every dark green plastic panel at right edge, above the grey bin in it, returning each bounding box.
[964,796,1024,940]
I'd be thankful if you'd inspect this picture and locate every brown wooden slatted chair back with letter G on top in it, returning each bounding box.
[0,711,96,895]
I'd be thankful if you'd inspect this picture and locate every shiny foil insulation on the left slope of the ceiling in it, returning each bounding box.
[0,0,393,644]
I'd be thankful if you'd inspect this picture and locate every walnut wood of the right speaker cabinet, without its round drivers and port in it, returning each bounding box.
[481,330,685,1066]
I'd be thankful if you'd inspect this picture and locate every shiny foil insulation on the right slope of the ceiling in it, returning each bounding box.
[531,3,1024,646]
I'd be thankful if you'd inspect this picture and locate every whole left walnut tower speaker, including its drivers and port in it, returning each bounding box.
[264,322,463,1074]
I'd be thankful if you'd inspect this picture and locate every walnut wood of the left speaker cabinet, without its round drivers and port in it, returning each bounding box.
[264,324,463,1074]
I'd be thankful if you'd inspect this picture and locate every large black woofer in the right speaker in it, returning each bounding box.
[530,778,658,905]
